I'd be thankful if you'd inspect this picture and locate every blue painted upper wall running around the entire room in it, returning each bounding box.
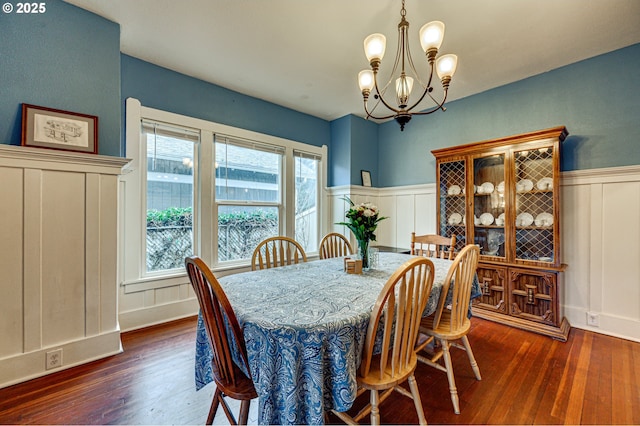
[0,0,640,187]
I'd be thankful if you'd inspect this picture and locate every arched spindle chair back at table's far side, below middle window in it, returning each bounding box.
[251,236,307,271]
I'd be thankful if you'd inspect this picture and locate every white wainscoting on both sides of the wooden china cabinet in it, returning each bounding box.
[330,166,640,341]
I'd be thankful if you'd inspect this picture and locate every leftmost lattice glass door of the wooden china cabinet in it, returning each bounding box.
[438,160,467,252]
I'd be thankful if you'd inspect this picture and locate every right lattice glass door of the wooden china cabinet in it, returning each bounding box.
[514,147,555,263]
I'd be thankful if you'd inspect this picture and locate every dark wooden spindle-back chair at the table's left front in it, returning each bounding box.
[185,256,258,425]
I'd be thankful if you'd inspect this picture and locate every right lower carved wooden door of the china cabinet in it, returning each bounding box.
[509,268,559,326]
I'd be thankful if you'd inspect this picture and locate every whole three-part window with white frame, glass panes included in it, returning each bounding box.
[120,99,327,292]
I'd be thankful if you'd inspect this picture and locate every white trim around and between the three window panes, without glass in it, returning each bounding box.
[119,98,328,293]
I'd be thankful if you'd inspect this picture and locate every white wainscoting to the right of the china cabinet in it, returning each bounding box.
[561,166,640,341]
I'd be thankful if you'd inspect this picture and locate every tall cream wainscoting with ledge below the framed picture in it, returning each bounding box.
[0,145,129,387]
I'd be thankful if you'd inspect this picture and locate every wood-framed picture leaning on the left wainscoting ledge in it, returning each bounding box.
[22,104,98,154]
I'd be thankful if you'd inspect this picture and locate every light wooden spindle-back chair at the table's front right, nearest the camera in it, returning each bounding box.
[333,257,434,425]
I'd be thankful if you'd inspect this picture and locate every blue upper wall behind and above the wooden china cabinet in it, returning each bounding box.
[378,44,640,187]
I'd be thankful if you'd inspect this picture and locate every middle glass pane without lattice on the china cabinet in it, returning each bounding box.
[473,154,506,257]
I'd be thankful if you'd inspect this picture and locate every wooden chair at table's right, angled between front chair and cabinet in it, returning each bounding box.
[416,244,482,414]
